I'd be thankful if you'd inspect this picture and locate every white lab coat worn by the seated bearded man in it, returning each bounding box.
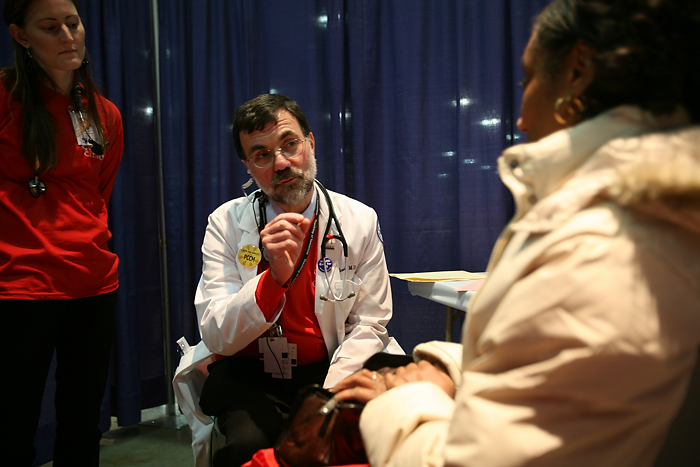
[173,186,403,466]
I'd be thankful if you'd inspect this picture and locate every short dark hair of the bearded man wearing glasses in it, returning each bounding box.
[233,94,311,160]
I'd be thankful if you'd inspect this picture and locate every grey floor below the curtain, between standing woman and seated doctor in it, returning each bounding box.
[41,406,194,467]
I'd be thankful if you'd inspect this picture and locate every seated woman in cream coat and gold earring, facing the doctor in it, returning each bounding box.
[336,0,700,467]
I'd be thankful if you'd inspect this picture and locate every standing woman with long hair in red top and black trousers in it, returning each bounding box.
[0,0,124,466]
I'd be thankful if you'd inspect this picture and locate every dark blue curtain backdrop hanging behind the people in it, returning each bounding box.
[0,0,549,465]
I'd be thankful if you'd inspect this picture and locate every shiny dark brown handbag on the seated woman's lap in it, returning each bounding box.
[274,385,367,467]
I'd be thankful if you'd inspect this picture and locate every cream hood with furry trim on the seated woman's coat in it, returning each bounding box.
[499,106,700,243]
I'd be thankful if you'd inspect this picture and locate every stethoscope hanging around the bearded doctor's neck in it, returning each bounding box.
[241,178,362,302]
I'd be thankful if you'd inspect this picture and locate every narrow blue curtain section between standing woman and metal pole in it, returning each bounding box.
[81,0,165,426]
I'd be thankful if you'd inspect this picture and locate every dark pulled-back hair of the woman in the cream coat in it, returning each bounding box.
[533,0,700,122]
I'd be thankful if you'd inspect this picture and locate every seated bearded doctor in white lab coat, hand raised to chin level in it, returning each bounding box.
[174,94,403,466]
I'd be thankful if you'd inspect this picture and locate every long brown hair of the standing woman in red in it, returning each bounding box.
[0,0,108,172]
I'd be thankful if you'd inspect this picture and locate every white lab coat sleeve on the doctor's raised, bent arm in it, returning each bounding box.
[195,207,285,355]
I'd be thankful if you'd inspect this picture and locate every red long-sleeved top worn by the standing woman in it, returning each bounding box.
[0,84,124,300]
